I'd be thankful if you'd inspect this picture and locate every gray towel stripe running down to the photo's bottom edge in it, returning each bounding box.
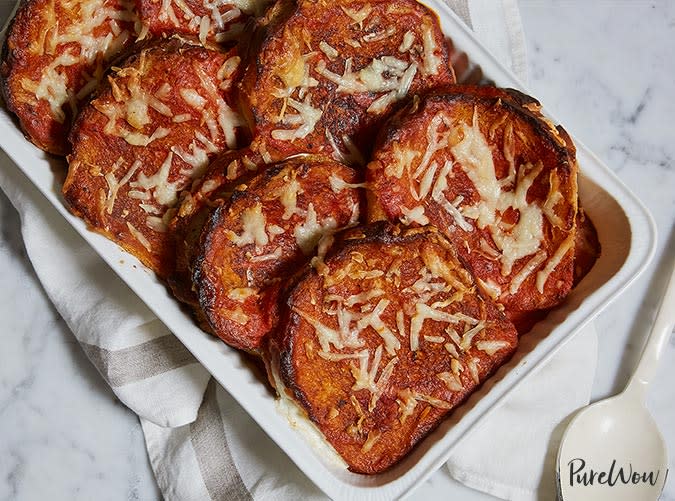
[190,378,253,501]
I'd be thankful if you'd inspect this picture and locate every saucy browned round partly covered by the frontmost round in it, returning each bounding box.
[194,157,360,352]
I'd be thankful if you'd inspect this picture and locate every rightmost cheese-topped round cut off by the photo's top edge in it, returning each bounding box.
[240,0,454,164]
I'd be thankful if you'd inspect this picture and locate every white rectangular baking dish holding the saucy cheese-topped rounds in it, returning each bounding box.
[0,0,656,500]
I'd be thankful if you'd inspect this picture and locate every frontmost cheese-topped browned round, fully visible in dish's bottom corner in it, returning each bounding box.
[278,223,518,474]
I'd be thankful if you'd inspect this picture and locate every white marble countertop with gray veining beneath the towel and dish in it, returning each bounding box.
[0,0,675,500]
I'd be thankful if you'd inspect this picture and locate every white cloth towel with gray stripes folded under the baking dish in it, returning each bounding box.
[0,0,596,500]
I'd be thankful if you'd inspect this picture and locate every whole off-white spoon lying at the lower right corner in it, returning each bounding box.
[558,258,675,501]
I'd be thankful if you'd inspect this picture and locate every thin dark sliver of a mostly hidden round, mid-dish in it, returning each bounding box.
[167,148,267,307]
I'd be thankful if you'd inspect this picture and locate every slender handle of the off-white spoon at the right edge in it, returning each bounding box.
[625,256,675,398]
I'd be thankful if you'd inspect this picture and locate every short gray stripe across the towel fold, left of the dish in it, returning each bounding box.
[82,334,197,388]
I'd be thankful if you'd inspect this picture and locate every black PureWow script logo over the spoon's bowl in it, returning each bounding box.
[561,458,668,487]
